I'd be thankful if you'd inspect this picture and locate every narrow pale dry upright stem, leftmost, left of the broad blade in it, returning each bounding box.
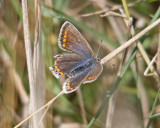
[22,0,35,128]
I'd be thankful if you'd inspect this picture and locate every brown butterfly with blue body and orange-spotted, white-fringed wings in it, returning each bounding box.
[49,21,103,94]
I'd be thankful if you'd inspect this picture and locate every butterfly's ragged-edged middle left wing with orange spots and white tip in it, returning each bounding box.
[49,53,83,78]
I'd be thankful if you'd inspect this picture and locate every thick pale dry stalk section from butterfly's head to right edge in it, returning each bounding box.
[101,18,160,64]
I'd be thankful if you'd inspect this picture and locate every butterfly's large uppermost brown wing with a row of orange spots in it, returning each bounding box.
[58,21,93,58]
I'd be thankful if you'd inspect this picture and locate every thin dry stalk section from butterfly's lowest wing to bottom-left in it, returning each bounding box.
[14,90,64,128]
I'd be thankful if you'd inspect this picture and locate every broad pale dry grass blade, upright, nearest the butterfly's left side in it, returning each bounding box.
[30,0,45,128]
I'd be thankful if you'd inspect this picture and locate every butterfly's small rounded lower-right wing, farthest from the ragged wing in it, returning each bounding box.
[83,61,103,83]
